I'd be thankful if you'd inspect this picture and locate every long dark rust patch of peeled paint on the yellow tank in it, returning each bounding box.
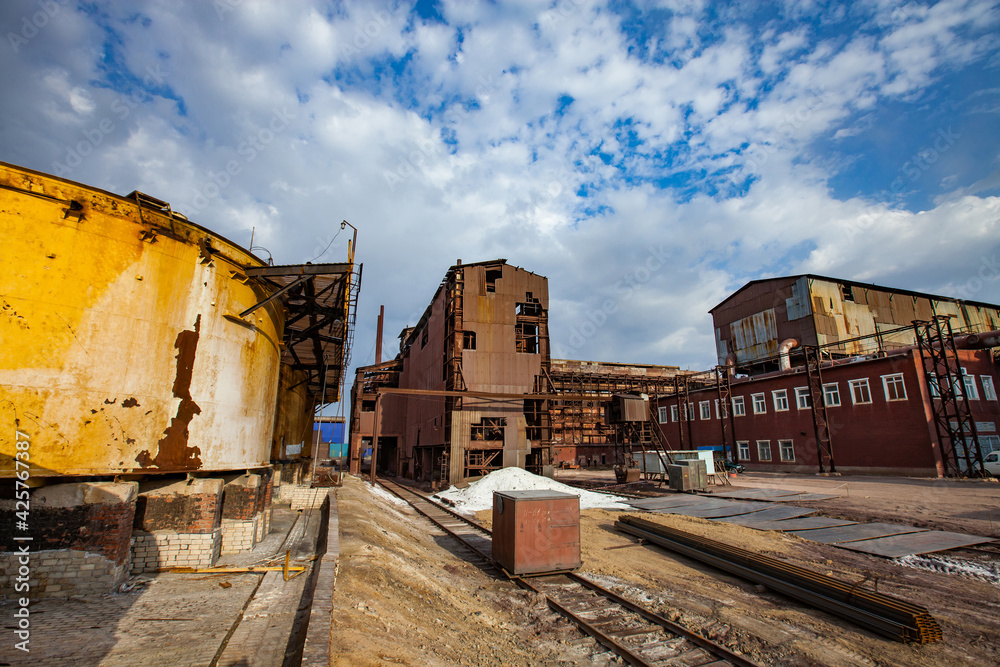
[135,314,201,470]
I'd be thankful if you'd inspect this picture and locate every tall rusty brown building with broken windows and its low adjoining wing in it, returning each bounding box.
[350,259,681,485]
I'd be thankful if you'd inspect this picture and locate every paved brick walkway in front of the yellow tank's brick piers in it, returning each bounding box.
[0,494,332,667]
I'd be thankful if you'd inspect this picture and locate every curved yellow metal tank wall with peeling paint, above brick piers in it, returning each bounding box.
[0,163,284,477]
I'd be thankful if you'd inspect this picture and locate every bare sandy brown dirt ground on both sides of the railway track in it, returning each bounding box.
[332,470,1000,667]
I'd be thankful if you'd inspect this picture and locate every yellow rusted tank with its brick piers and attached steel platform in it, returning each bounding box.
[0,163,361,596]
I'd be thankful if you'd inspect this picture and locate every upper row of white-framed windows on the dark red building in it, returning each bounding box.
[657,368,997,424]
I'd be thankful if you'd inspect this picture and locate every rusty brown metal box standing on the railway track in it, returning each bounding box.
[493,490,583,575]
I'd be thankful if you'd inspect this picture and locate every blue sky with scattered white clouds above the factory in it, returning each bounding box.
[0,0,1000,410]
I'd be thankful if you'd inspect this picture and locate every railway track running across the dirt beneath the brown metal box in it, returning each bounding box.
[379,479,756,667]
